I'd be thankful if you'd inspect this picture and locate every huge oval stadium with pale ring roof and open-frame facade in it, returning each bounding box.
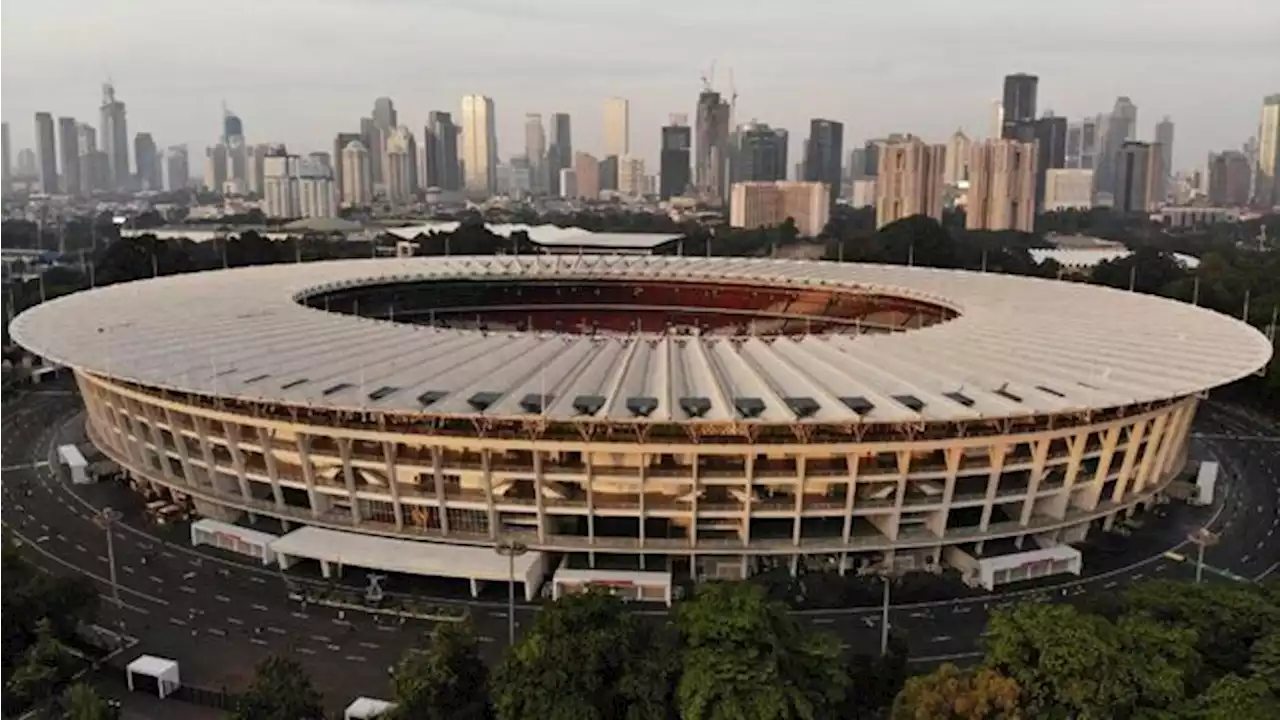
[12,255,1271,591]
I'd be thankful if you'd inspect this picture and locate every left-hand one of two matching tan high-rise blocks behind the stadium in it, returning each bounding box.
[876,135,947,228]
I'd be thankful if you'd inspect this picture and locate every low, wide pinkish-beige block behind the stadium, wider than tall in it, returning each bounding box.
[728,181,831,237]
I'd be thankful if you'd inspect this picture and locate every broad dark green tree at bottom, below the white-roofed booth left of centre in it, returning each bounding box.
[493,593,678,720]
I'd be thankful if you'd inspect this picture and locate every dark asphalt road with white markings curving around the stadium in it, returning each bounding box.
[0,389,1280,705]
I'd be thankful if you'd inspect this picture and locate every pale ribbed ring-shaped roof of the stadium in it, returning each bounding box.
[12,255,1271,423]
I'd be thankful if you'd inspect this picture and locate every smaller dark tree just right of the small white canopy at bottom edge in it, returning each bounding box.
[387,623,490,720]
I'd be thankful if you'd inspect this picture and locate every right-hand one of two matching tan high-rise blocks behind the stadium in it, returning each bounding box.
[965,140,1037,232]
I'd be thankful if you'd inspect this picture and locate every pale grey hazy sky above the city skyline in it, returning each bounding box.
[0,0,1280,173]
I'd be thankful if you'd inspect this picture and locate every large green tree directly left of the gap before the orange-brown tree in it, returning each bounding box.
[677,583,849,720]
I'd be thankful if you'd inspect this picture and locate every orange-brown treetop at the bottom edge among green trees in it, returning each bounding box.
[892,662,1029,720]
